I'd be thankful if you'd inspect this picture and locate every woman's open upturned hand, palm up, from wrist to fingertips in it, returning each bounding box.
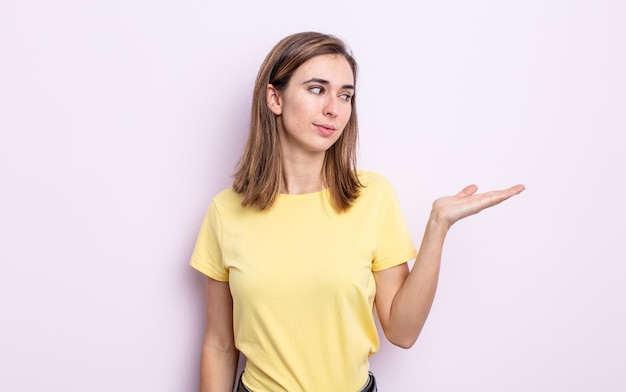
[431,184,526,228]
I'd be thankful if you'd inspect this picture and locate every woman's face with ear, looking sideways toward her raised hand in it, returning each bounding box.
[267,54,354,158]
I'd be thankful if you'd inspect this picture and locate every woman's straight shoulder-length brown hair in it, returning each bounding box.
[233,32,363,211]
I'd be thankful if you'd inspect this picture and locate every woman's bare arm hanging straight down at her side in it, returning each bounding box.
[200,277,239,392]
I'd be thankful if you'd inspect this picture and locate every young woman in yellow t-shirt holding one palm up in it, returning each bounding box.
[191,32,524,392]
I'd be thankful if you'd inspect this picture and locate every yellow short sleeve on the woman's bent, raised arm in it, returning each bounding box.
[372,185,417,271]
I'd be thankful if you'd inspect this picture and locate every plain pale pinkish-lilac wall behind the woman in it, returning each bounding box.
[0,0,626,392]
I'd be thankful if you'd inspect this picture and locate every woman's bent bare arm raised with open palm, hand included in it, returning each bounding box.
[374,185,524,348]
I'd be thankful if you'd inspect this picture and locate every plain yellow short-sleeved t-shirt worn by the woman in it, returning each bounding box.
[191,171,416,392]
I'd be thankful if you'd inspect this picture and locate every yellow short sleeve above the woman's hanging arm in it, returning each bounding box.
[190,201,228,282]
